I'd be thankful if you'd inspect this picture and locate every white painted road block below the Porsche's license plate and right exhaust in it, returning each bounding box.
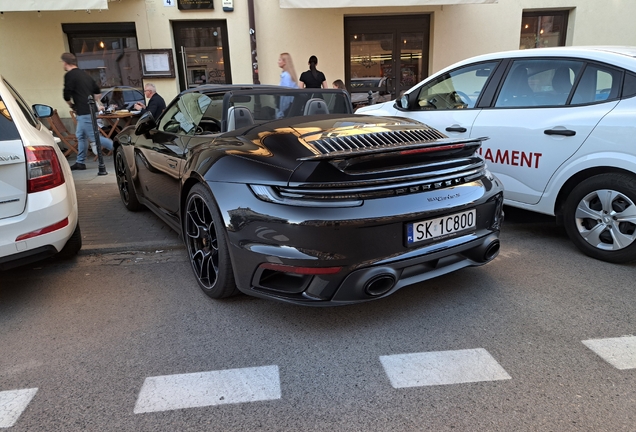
[380,348,512,388]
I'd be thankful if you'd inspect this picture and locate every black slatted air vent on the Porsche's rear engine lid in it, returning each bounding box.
[312,129,446,154]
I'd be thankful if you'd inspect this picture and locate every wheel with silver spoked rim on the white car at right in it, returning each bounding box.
[563,173,636,263]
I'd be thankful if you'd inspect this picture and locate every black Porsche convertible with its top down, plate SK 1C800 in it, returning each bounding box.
[115,85,503,306]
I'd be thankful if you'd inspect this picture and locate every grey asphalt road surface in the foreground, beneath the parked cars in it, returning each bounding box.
[0,209,636,431]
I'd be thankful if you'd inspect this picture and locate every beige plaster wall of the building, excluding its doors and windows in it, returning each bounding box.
[0,0,636,116]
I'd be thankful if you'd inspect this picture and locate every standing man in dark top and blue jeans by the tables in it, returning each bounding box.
[62,53,113,170]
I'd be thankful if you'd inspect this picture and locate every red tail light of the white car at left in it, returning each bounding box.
[26,146,64,193]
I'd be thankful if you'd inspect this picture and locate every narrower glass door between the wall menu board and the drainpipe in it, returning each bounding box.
[172,21,232,90]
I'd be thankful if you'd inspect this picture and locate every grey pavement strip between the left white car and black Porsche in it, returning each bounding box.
[69,154,184,254]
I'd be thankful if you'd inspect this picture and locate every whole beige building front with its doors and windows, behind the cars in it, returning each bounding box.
[0,0,636,117]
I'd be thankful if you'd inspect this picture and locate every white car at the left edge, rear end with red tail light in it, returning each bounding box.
[0,76,82,270]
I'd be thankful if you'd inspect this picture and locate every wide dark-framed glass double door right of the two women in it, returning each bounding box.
[345,15,430,106]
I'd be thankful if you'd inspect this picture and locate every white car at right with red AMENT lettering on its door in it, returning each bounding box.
[356,47,636,262]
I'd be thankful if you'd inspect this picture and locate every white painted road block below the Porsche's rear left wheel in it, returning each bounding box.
[134,366,281,414]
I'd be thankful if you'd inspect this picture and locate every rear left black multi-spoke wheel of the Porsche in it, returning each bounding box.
[183,183,239,299]
